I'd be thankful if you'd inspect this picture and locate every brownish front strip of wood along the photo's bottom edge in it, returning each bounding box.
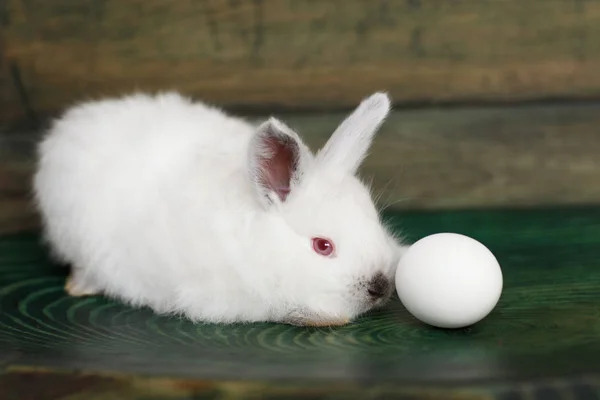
[0,363,600,400]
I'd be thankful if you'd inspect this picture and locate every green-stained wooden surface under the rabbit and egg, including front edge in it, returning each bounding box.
[0,208,600,399]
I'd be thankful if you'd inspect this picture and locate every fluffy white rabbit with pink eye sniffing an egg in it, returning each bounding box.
[34,93,404,326]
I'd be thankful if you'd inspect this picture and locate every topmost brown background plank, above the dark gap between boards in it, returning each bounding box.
[0,0,600,120]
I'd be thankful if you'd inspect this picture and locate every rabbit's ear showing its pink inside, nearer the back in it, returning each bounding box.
[248,118,312,206]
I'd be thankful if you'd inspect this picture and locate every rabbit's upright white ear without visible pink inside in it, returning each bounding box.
[317,92,391,174]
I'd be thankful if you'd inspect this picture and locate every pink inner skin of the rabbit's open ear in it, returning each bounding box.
[259,137,295,201]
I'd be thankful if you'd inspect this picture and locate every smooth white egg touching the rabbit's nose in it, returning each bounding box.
[396,233,503,328]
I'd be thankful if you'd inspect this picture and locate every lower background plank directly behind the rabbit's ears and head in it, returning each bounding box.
[0,103,600,236]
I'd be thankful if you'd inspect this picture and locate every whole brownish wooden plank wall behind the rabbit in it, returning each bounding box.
[0,0,600,232]
